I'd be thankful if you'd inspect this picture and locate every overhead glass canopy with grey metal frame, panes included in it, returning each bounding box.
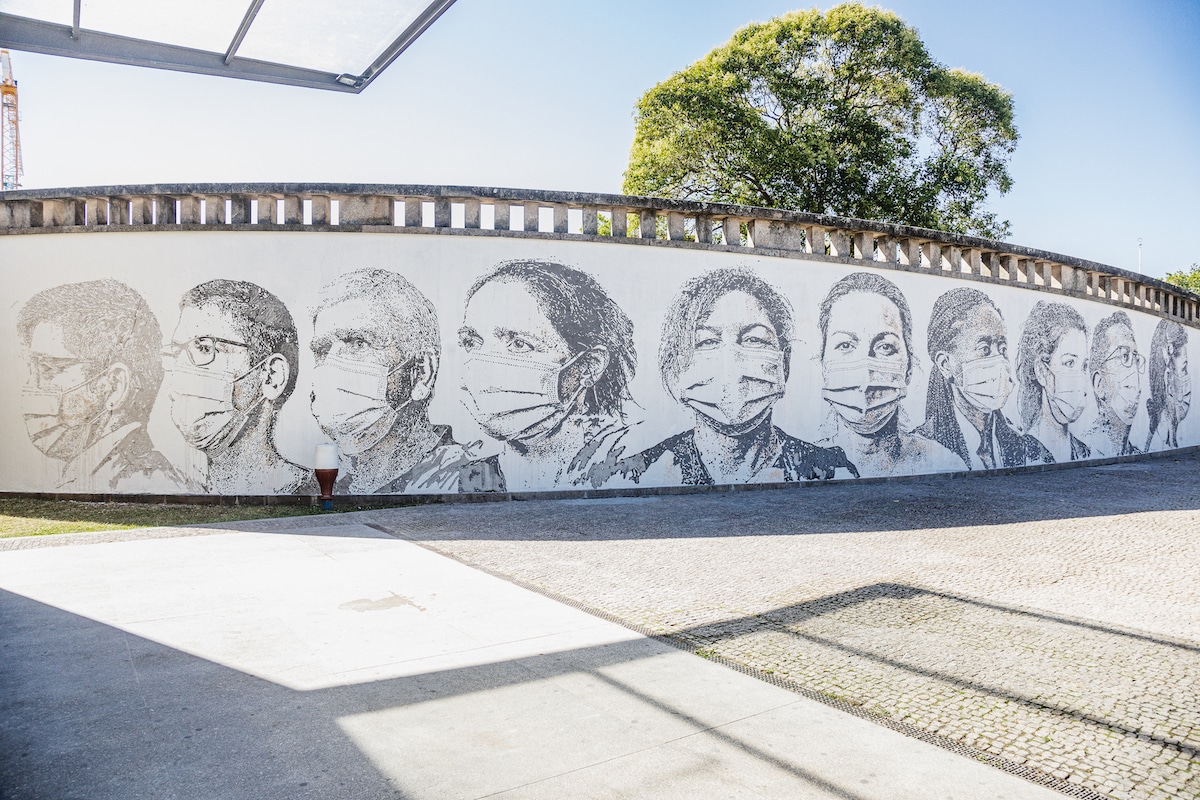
[0,0,454,92]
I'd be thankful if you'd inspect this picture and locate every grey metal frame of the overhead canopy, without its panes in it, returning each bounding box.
[0,0,455,95]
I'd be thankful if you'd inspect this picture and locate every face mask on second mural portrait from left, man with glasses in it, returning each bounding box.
[167,360,266,450]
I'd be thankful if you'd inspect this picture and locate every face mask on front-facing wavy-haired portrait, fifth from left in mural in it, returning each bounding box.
[679,344,784,427]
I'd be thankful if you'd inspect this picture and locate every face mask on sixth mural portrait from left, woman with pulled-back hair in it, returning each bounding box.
[821,357,908,435]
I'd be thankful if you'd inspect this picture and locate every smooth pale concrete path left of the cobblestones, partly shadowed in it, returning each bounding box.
[0,515,1061,800]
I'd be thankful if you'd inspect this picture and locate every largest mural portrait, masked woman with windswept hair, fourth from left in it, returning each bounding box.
[458,260,637,491]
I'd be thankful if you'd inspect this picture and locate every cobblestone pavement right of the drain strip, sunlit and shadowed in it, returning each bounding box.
[355,455,1200,799]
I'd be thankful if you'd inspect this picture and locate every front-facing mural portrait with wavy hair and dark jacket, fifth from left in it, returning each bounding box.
[614,269,858,486]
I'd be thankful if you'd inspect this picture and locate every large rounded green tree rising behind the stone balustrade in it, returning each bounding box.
[624,2,1018,239]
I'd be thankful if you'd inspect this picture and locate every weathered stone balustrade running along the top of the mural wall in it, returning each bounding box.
[0,184,1200,326]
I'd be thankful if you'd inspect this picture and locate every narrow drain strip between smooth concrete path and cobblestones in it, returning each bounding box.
[365,523,1111,800]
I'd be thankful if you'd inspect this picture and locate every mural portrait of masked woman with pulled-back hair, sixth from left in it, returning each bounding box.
[817,272,958,475]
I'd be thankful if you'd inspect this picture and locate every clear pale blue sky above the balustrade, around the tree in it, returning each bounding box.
[13,0,1200,276]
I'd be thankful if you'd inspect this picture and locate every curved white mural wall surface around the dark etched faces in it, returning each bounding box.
[0,230,1200,494]
